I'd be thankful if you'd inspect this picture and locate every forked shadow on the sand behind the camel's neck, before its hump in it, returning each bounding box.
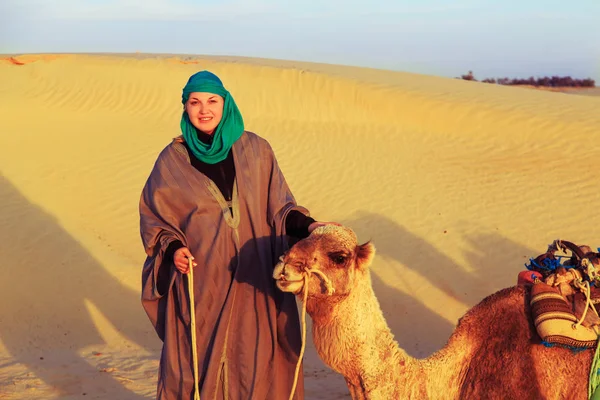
[340,212,537,358]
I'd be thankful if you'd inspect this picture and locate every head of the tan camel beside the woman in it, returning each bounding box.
[273,225,375,297]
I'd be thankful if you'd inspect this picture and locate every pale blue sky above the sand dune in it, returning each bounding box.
[0,0,600,81]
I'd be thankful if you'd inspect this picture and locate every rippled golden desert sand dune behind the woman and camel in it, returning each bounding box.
[0,54,600,400]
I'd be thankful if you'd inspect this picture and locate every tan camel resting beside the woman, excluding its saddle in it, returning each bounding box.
[273,225,594,400]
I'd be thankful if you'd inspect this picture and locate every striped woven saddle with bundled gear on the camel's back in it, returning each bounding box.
[520,240,600,348]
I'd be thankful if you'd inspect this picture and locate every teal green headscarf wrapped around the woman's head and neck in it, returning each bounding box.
[181,71,244,164]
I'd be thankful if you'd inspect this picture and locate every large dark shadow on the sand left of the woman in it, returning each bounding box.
[0,176,160,400]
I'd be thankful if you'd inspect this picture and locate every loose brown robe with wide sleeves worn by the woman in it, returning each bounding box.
[140,132,308,400]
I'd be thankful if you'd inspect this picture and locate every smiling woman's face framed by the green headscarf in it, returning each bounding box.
[185,92,224,135]
